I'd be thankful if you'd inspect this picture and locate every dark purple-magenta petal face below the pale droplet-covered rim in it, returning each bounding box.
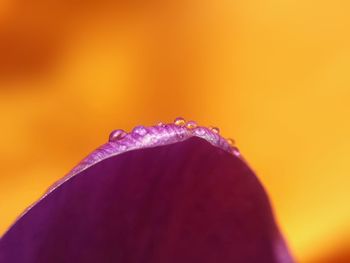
[0,137,293,263]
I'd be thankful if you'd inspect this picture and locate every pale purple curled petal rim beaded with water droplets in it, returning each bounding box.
[45,117,244,206]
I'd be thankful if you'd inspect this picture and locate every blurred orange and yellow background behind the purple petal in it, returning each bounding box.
[0,0,350,262]
